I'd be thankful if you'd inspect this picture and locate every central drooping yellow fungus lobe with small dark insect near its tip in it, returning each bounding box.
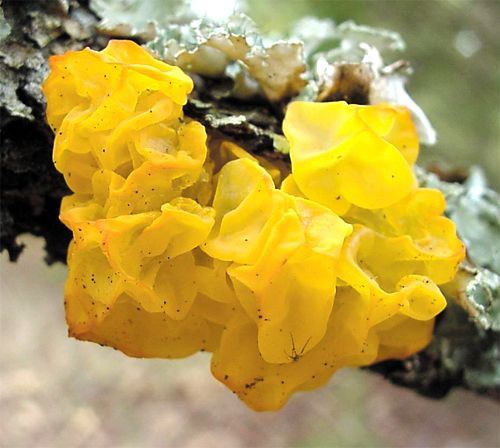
[203,158,352,363]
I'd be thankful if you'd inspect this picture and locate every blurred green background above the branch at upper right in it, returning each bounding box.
[247,0,500,190]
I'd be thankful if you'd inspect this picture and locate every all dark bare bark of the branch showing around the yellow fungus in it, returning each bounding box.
[0,0,500,399]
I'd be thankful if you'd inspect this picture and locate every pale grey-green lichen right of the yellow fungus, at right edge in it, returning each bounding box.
[417,164,500,346]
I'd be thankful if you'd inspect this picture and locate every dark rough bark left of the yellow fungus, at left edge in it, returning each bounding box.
[0,0,105,263]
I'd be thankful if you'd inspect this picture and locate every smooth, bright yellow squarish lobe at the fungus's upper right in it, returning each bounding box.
[283,101,416,215]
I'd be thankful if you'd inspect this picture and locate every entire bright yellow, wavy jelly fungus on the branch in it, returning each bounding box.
[43,41,464,410]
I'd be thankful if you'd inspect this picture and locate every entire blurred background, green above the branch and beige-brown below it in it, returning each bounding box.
[0,0,500,448]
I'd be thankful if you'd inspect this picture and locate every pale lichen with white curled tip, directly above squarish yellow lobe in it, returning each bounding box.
[293,17,436,145]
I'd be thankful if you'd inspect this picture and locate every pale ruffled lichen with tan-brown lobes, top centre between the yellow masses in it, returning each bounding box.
[147,13,306,102]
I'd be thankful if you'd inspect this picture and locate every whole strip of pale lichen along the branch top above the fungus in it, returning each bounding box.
[91,0,436,133]
